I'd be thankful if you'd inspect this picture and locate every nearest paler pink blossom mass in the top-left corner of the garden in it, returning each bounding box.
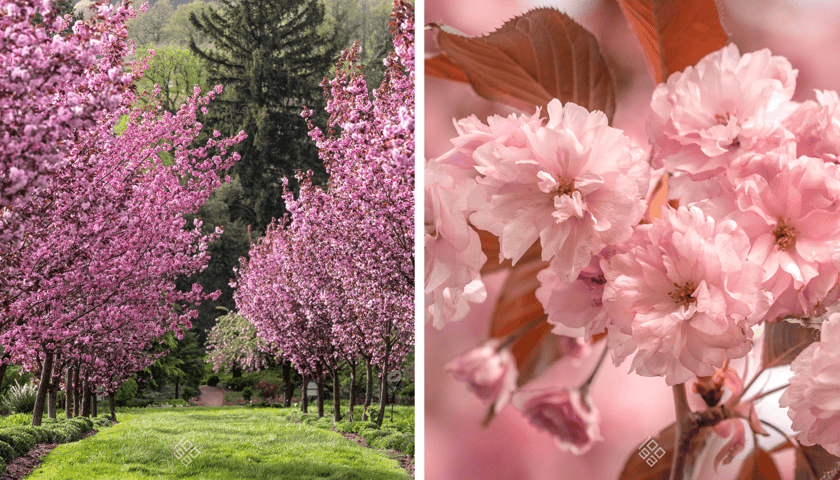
[0,0,133,214]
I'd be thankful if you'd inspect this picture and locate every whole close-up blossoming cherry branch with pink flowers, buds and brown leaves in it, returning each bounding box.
[424,0,840,480]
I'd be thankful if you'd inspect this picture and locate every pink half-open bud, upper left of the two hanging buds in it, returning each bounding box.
[445,339,519,412]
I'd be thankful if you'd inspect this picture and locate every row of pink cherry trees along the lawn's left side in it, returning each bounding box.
[0,2,245,425]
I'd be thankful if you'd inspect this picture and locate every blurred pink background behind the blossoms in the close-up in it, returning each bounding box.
[424,0,840,480]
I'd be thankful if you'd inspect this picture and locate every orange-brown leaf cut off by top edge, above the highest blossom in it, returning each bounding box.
[618,0,727,83]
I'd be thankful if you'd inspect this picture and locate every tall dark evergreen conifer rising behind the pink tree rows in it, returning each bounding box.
[190,0,338,232]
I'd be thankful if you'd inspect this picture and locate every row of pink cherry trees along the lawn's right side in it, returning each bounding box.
[235,0,414,423]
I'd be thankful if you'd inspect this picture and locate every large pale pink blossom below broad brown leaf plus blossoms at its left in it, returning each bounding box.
[425,100,650,327]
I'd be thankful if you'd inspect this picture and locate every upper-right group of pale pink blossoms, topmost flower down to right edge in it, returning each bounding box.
[648,45,840,321]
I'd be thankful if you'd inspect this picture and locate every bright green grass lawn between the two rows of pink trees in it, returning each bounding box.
[26,407,411,480]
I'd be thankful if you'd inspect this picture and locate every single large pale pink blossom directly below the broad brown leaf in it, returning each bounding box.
[470,100,650,282]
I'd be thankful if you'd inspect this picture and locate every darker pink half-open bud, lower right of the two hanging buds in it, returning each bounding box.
[512,388,602,455]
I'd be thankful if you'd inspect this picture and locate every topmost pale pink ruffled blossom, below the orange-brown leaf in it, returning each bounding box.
[648,43,797,180]
